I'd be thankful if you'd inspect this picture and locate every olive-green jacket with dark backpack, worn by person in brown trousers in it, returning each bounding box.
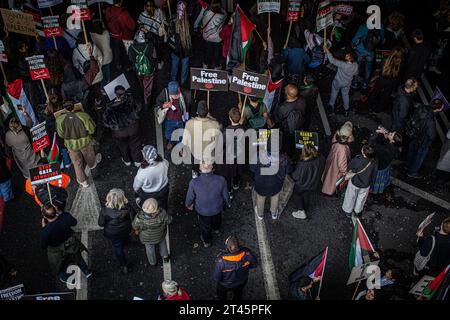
[56,112,95,151]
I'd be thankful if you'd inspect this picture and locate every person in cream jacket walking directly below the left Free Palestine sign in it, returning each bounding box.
[181,100,221,178]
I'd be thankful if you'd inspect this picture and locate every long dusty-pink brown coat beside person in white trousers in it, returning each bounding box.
[322,136,351,196]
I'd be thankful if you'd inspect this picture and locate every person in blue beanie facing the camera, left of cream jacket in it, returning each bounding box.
[156,81,191,150]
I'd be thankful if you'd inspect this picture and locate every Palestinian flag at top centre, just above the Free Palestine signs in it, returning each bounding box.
[227,5,256,70]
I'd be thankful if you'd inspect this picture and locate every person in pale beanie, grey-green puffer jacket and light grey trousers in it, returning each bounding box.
[132,198,172,267]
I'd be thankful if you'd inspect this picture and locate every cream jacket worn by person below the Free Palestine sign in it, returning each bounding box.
[182,117,221,160]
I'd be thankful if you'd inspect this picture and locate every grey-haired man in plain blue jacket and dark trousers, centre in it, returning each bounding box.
[185,162,231,248]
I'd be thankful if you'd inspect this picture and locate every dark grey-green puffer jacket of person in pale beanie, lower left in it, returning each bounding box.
[132,209,172,244]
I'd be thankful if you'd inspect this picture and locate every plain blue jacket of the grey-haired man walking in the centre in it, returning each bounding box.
[186,173,230,217]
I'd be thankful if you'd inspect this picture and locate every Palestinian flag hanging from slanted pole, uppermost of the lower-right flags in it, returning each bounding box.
[349,218,375,272]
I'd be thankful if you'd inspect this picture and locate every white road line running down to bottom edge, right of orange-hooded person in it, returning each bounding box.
[255,213,281,300]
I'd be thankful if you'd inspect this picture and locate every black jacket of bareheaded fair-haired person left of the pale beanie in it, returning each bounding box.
[98,206,135,239]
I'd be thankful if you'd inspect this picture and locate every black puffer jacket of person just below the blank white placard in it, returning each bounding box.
[103,93,142,131]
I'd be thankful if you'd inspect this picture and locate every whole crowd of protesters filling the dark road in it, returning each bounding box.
[0,0,450,300]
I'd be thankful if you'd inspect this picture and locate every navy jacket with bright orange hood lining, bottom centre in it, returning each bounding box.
[213,247,257,289]
